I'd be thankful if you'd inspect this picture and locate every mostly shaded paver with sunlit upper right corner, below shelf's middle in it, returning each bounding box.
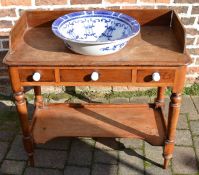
[94,150,118,165]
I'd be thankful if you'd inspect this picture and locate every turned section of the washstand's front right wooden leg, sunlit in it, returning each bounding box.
[163,93,181,169]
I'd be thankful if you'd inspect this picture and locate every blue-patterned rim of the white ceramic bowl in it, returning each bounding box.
[51,10,140,44]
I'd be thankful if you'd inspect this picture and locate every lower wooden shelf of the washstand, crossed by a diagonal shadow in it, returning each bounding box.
[31,104,166,145]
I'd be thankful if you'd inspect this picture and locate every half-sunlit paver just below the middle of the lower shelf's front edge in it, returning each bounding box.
[95,138,120,150]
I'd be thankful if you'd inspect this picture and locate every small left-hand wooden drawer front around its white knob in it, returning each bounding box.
[19,69,55,82]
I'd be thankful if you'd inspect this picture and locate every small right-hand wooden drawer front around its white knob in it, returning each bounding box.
[136,69,175,83]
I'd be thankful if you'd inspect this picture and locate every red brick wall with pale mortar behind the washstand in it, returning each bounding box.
[0,0,199,83]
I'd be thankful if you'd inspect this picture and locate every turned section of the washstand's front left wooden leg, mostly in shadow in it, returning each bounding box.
[14,91,34,166]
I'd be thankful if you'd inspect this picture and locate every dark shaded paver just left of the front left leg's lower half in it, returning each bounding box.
[6,135,28,160]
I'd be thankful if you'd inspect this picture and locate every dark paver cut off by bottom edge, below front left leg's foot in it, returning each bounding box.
[24,167,62,175]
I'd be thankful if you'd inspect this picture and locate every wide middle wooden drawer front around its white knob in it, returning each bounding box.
[60,69,132,83]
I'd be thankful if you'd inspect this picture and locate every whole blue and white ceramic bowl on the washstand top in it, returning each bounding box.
[52,10,140,55]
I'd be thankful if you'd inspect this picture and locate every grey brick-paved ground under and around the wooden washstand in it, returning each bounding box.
[0,93,199,175]
